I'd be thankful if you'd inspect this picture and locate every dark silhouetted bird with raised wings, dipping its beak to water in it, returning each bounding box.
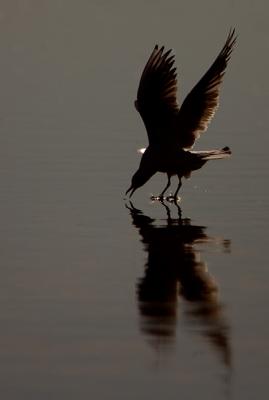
[126,28,236,201]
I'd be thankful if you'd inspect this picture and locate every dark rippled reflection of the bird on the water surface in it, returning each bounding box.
[126,203,231,366]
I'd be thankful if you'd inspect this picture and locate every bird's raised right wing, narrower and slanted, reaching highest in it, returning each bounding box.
[177,29,236,149]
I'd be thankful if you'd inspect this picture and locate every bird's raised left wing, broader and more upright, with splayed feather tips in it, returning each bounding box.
[135,45,179,143]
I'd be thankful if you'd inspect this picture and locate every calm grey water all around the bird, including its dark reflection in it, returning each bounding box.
[0,0,269,400]
